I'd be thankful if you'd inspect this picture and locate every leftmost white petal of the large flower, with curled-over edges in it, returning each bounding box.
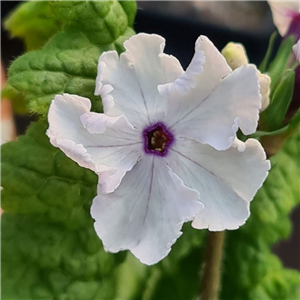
[47,94,142,193]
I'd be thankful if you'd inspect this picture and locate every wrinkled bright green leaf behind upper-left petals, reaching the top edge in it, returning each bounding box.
[2,0,136,114]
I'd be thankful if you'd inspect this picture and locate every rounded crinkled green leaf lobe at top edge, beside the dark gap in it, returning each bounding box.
[49,0,136,46]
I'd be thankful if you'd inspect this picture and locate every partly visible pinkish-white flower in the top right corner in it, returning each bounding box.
[268,0,300,41]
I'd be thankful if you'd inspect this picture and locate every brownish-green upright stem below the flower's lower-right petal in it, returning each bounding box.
[200,231,225,300]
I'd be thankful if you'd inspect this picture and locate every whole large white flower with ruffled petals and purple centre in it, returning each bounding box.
[47,34,270,264]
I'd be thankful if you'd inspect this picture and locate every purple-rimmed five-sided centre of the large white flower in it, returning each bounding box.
[143,123,174,156]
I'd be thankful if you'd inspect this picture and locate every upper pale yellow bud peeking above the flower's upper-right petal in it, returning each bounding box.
[222,42,249,70]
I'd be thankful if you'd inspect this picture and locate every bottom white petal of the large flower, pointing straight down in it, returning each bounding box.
[91,156,203,265]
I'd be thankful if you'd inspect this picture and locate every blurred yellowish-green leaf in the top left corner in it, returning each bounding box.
[4,0,63,51]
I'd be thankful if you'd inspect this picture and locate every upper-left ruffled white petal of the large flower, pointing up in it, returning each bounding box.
[95,33,183,127]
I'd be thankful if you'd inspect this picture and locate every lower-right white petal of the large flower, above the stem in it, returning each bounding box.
[167,138,270,231]
